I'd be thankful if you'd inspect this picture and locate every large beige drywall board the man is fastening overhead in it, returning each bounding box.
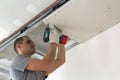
[44,0,120,43]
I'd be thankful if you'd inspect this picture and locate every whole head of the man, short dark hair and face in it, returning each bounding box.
[14,36,35,55]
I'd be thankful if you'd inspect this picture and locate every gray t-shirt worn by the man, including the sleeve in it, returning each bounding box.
[10,55,45,80]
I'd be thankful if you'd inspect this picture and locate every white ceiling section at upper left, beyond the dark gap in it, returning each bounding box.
[0,0,57,41]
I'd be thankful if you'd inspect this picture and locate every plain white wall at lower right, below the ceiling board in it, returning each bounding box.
[47,24,120,80]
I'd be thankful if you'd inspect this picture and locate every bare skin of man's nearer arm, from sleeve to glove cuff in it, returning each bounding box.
[26,44,57,71]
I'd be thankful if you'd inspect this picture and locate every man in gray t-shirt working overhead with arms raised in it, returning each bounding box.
[10,27,65,80]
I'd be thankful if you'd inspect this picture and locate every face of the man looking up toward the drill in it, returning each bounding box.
[21,37,35,55]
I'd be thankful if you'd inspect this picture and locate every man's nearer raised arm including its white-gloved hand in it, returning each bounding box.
[27,26,59,71]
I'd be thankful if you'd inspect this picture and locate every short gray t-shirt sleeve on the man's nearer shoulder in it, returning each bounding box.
[11,55,32,71]
